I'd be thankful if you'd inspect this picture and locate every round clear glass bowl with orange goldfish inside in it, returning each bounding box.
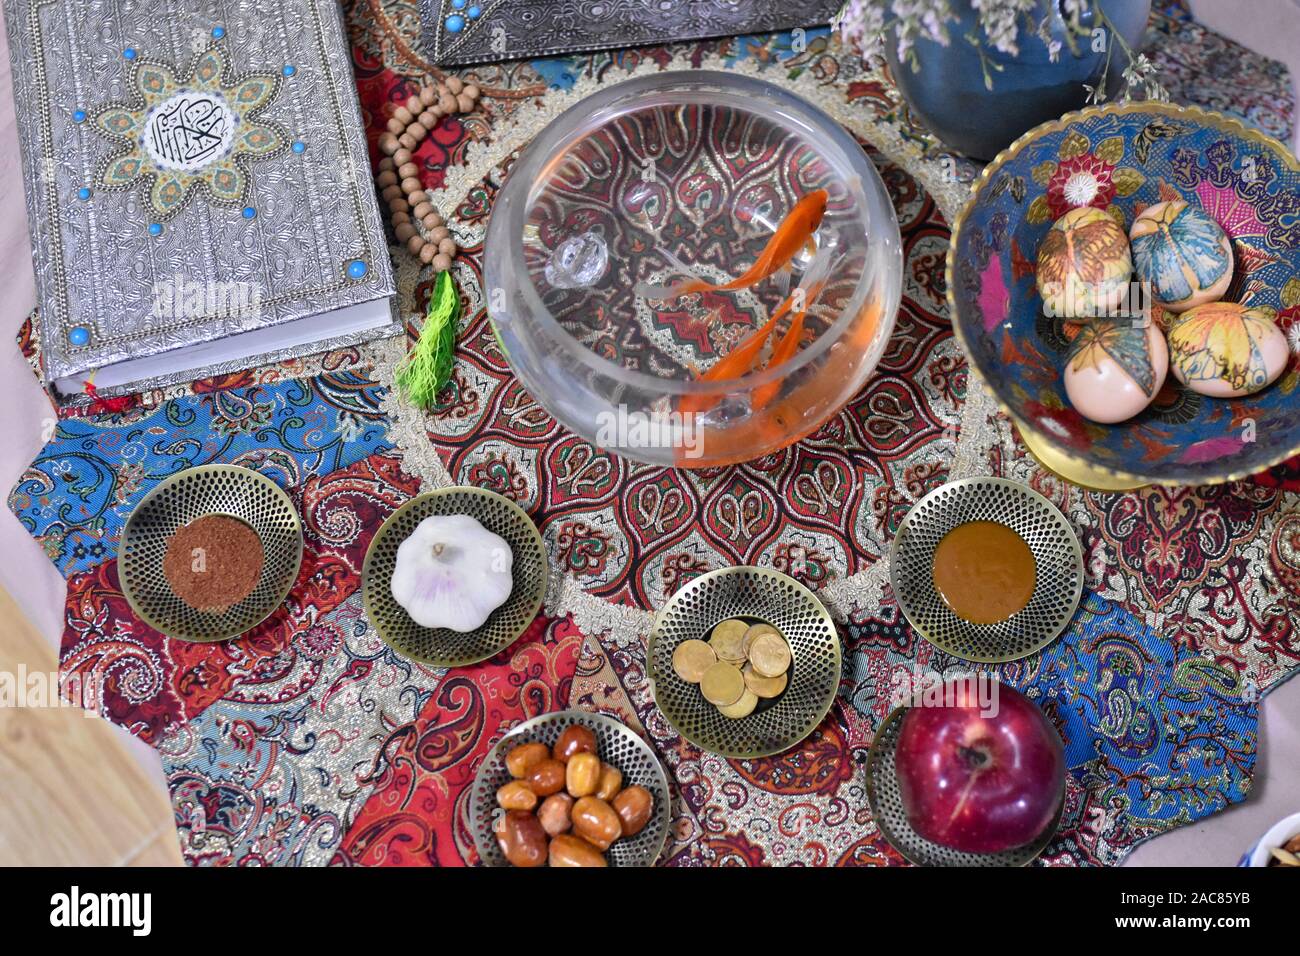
[484,70,902,468]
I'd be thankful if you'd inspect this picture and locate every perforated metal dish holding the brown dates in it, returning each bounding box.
[469,710,672,866]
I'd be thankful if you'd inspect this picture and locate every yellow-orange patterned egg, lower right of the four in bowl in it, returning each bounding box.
[1169,302,1291,398]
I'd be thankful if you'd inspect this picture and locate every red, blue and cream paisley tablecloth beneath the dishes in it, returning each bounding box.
[9,0,1300,865]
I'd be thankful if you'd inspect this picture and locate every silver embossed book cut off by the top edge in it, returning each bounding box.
[420,0,844,66]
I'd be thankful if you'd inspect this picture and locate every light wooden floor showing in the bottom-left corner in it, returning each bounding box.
[0,589,181,866]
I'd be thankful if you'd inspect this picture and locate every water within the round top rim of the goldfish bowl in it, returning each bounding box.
[524,103,866,390]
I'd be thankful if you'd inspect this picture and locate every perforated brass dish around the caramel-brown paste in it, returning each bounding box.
[889,477,1083,663]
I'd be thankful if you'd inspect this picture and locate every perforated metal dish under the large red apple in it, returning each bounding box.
[866,706,1065,866]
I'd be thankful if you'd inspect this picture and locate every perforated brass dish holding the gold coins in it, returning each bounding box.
[646,567,840,757]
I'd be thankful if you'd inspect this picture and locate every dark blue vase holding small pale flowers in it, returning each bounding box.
[885,0,1151,160]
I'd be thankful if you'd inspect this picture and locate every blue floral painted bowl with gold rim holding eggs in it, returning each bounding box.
[948,103,1300,488]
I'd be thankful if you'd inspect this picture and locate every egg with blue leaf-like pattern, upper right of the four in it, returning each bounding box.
[1128,199,1232,312]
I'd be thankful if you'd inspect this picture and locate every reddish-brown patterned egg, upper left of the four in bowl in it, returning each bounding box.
[1036,206,1134,319]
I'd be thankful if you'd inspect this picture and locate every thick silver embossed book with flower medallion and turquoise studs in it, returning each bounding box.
[4,0,400,393]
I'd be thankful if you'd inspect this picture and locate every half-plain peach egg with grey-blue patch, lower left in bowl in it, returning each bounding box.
[1065,319,1169,425]
